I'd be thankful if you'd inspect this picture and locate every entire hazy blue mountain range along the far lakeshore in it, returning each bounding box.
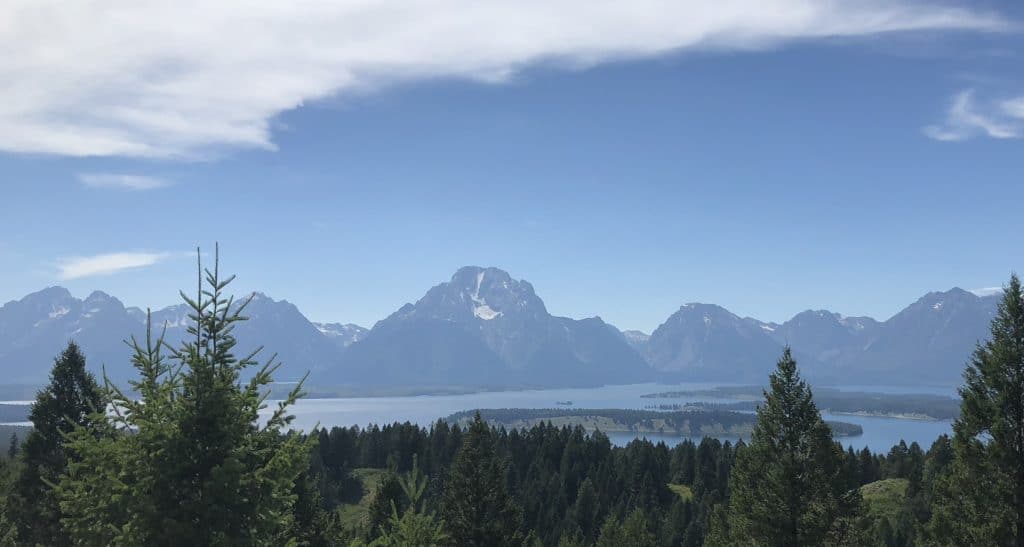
[0,266,999,388]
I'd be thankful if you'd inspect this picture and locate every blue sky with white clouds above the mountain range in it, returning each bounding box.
[0,0,1024,331]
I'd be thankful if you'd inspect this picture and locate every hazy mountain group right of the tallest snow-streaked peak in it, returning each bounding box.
[645,288,1001,385]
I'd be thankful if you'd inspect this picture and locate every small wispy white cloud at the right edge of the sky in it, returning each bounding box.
[923,89,1024,141]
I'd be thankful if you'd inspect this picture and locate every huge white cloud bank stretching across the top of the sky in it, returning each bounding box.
[0,0,1009,157]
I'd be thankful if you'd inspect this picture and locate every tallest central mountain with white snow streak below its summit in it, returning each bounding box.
[339,266,649,385]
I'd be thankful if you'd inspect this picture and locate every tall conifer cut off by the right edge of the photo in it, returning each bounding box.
[928,275,1024,547]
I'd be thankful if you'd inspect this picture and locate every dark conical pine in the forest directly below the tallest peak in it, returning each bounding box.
[441,413,521,547]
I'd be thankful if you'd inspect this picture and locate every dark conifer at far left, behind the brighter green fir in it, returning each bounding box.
[7,342,102,545]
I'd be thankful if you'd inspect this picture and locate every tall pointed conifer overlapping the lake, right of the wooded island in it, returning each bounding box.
[711,347,858,547]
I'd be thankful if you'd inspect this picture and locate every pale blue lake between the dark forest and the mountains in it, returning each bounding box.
[270,383,954,452]
